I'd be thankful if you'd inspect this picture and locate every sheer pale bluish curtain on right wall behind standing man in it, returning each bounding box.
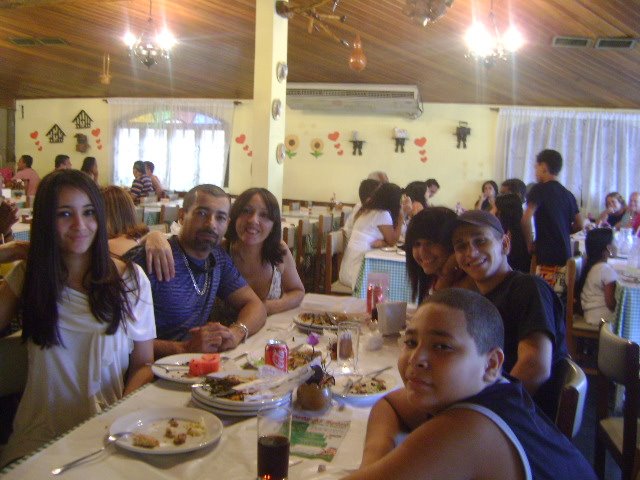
[496,107,640,213]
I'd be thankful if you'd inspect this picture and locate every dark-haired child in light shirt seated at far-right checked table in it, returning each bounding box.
[576,228,618,325]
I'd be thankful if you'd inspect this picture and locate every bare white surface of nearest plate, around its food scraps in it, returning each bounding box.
[109,407,223,455]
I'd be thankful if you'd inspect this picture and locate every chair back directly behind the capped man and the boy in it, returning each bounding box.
[556,358,587,440]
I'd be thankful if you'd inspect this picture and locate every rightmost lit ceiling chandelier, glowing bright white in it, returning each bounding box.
[465,0,524,67]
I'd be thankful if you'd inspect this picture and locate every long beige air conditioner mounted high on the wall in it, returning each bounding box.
[287,83,422,118]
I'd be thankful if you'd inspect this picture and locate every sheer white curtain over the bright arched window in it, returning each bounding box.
[108,98,234,191]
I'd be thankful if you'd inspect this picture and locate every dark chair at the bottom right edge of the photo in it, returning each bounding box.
[594,323,640,480]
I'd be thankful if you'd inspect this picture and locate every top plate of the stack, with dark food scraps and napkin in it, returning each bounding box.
[191,371,290,410]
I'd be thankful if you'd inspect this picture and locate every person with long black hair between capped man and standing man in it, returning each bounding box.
[496,192,531,273]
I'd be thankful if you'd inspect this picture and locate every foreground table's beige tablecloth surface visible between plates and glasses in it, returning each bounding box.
[0,294,401,480]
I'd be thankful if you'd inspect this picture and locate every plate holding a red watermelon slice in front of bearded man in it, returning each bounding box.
[151,353,222,384]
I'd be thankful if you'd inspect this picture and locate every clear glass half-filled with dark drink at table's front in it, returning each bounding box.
[258,407,291,480]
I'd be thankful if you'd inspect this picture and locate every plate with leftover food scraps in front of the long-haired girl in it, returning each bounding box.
[109,407,223,455]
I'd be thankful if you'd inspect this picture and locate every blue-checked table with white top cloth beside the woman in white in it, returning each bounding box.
[353,247,412,303]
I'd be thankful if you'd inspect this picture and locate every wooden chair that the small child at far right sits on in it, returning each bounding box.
[565,256,599,375]
